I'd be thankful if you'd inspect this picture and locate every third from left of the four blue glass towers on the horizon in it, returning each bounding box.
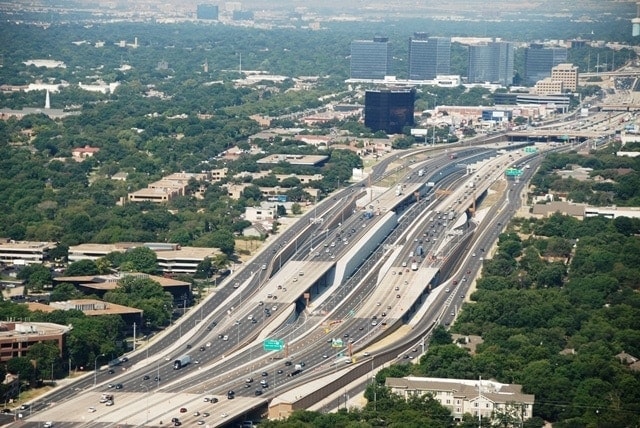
[467,42,514,86]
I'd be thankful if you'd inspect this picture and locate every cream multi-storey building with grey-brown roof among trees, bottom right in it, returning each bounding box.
[386,376,535,422]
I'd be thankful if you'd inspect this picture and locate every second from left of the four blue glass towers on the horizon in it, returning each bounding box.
[409,33,451,80]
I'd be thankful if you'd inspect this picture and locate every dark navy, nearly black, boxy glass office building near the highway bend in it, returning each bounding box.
[364,88,416,134]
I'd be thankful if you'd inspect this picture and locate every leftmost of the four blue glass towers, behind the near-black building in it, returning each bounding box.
[351,36,393,79]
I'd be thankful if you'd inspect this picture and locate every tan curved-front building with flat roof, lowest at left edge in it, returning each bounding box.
[0,322,71,363]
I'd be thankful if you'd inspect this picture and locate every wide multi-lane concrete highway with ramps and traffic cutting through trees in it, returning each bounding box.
[13,140,576,426]
